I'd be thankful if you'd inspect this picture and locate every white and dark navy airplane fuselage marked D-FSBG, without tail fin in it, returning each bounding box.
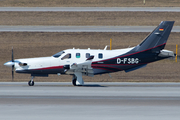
[11,47,174,76]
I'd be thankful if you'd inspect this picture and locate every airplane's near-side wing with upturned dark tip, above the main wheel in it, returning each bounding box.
[65,56,94,76]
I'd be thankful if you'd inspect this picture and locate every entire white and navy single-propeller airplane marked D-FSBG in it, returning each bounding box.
[4,21,175,86]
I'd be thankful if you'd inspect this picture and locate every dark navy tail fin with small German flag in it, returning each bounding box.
[136,21,174,52]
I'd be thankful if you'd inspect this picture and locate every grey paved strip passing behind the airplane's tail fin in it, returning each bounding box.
[0,25,180,32]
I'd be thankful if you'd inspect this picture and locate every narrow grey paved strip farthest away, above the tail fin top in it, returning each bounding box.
[0,7,180,12]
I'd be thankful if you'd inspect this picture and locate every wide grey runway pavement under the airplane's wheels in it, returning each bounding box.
[0,82,180,120]
